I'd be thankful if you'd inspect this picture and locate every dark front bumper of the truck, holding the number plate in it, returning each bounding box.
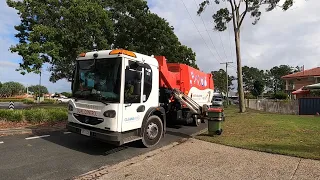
[66,122,136,146]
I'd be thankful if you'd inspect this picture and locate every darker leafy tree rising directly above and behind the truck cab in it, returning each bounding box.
[106,0,198,69]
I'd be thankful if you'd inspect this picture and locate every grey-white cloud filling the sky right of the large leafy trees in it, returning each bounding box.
[148,0,320,75]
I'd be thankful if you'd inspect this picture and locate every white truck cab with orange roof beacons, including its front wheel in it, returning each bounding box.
[67,50,166,147]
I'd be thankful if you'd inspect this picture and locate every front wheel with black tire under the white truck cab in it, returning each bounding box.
[142,116,163,148]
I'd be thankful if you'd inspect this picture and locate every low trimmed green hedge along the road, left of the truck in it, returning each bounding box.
[0,108,68,124]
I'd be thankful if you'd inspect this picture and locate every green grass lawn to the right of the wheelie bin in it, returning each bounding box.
[197,106,320,160]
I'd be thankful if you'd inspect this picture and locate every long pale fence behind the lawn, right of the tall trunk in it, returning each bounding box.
[245,99,299,115]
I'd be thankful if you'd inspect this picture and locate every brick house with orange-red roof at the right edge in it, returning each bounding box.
[281,67,320,98]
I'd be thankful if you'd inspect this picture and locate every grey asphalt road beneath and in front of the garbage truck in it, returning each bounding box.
[0,124,207,180]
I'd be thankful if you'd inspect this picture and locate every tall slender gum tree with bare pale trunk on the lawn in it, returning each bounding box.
[197,0,293,112]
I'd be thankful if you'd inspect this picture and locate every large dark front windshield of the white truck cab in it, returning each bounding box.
[72,58,122,103]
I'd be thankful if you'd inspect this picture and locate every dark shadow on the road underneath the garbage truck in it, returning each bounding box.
[30,121,204,156]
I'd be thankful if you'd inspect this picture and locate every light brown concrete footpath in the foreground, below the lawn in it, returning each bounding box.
[75,139,320,180]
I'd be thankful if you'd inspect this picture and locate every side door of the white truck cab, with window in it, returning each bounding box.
[122,60,146,132]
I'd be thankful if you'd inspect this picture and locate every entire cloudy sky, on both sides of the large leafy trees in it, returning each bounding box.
[0,0,320,92]
